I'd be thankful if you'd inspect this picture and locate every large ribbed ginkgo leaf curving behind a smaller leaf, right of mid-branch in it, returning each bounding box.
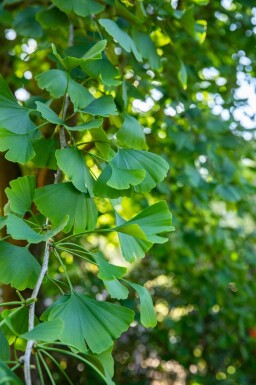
[111,149,169,192]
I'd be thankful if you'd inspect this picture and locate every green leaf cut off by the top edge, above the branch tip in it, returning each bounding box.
[53,0,105,17]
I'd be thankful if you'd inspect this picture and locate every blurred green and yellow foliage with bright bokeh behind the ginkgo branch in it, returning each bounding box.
[0,0,255,385]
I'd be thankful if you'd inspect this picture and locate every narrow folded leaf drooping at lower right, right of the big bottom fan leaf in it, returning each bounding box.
[125,281,157,328]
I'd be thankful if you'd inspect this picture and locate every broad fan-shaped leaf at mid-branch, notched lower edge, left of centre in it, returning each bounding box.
[34,182,98,233]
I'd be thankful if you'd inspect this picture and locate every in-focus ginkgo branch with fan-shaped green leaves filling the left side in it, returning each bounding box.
[0,0,174,385]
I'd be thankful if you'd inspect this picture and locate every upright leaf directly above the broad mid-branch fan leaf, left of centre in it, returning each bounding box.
[56,147,94,196]
